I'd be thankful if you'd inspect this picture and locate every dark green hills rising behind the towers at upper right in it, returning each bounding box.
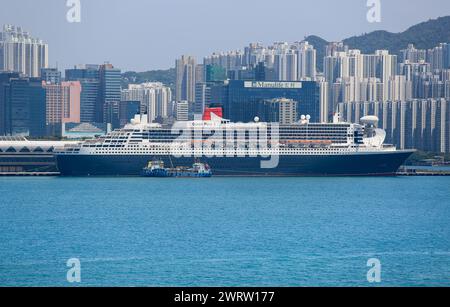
[305,16,450,71]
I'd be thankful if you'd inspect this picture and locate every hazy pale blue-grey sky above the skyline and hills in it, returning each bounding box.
[0,0,450,71]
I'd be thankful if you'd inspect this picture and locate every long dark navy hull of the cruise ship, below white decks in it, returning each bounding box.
[56,151,412,176]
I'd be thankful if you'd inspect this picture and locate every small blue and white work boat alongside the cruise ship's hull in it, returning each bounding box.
[142,160,212,178]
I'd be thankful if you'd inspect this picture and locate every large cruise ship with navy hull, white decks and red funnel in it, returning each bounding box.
[55,111,413,176]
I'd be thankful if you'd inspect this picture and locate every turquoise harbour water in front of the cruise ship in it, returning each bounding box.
[0,177,450,286]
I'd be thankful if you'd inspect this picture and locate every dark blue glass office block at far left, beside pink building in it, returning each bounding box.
[4,78,46,137]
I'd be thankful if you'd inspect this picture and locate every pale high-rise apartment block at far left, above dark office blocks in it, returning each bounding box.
[0,25,48,77]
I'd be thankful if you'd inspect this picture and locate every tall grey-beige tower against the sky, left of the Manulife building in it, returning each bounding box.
[175,55,197,102]
